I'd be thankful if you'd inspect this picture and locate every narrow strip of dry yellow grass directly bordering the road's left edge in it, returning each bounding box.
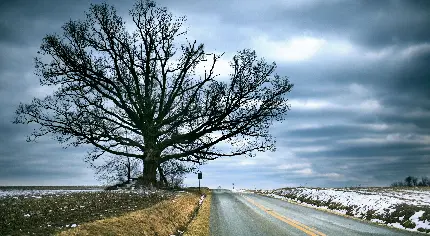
[184,189,212,236]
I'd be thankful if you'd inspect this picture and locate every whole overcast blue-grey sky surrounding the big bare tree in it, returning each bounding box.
[0,0,430,188]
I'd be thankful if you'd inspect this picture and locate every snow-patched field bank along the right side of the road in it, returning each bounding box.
[257,188,430,233]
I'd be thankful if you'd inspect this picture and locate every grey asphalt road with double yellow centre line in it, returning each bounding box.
[210,189,422,236]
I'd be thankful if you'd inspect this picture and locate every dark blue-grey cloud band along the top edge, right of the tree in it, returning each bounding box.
[161,0,430,48]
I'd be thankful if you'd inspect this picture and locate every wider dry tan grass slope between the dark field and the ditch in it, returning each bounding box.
[59,193,200,236]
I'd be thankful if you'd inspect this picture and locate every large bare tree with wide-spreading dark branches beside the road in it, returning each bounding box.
[15,0,293,184]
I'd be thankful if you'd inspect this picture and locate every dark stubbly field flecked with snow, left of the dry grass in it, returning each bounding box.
[0,187,171,235]
